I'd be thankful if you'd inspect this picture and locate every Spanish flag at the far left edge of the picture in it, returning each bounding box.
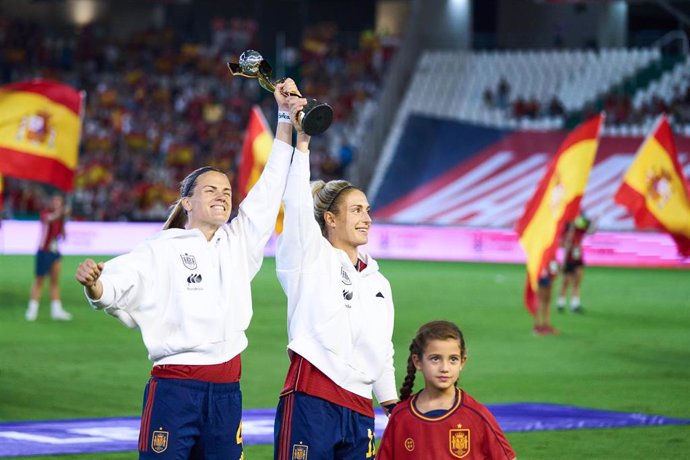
[0,80,83,191]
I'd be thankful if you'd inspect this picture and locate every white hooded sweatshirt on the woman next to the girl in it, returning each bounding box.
[276,150,398,402]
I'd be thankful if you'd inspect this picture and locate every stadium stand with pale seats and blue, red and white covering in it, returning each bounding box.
[369,44,690,230]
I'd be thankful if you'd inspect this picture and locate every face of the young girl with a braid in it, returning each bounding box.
[412,339,467,393]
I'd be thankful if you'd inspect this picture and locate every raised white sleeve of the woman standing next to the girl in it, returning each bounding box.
[276,146,325,272]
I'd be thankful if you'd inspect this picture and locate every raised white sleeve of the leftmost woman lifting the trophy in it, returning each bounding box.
[230,139,293,277]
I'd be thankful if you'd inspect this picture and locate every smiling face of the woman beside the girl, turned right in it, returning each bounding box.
[324,188,371,254]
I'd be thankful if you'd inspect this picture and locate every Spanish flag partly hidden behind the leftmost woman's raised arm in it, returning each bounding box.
[237,105,283,234]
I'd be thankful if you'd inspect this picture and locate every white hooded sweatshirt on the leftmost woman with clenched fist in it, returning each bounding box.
[87,139,293,365]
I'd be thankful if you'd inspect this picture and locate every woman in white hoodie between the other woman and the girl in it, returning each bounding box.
[274,68,397,460]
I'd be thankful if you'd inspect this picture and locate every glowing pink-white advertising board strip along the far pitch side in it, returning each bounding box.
[0,220,690,268]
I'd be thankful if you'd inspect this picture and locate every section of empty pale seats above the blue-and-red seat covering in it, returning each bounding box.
[382,48,661,130]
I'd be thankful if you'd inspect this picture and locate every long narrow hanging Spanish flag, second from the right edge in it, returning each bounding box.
[515,115,604,315]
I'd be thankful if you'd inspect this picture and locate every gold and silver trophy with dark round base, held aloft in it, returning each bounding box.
[228,50,333,136]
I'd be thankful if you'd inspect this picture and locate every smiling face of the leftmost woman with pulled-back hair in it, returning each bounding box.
[182,171,232,238]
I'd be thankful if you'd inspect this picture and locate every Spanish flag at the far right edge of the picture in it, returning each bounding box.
[614,115,690,257]
